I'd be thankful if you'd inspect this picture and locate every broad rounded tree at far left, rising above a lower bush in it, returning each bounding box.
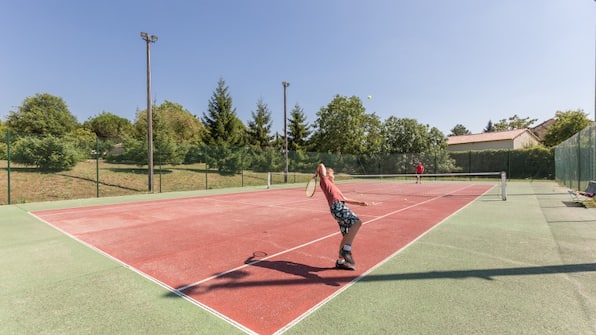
[7,93,79,136]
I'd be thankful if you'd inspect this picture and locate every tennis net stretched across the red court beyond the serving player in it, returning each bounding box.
[267,172,507,200]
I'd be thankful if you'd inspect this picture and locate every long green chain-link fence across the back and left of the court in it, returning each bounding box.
[0,132,554,204]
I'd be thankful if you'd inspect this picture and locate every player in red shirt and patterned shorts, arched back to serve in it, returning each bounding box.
[315,163,368,270]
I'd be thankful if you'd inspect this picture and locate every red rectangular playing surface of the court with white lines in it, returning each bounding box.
[33,183,494,334]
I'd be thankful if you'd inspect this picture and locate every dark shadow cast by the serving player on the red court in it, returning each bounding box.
[244,256,340,286]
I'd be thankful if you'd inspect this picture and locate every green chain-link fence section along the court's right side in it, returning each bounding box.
[555,125,596,190]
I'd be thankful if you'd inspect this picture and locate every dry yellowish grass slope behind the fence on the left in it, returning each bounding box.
[0,160,267,205]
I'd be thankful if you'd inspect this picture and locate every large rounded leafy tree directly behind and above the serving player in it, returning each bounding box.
[313,95,371,155]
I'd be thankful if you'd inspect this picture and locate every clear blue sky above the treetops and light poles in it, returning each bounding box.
[0,0,596,135]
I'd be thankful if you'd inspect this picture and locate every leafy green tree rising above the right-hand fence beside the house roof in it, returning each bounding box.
[544,109,592,147]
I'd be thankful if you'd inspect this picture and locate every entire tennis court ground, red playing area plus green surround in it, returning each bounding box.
[1,181,596,334]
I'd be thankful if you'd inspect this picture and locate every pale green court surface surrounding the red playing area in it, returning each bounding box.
[0,181,596,334]
